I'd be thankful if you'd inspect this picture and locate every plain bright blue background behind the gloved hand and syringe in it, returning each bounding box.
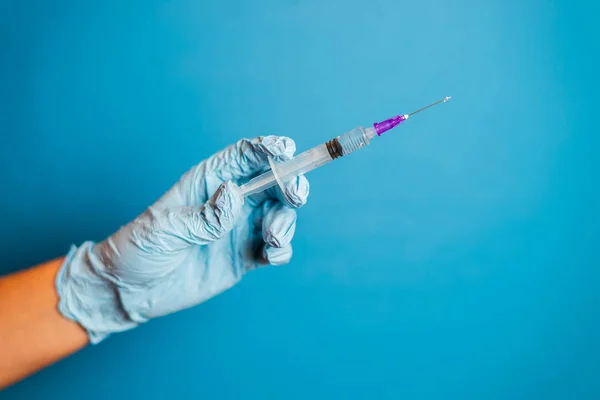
[0,0,600,400]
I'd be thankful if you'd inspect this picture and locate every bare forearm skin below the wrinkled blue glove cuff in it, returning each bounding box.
[0,258,88,388]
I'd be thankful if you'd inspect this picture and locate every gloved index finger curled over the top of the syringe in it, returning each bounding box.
[206,136,296,181]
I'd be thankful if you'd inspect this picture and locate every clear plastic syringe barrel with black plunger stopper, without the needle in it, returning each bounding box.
[240,126,376,196]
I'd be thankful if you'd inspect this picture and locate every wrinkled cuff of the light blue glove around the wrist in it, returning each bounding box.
[56,242,138,344]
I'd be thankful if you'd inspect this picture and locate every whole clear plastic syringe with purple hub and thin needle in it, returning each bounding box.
[239,96,450,203]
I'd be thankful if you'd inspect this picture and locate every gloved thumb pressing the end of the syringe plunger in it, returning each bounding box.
[168,181,244,244]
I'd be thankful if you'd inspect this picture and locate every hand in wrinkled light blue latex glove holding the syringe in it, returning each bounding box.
[56,136,309,343]
